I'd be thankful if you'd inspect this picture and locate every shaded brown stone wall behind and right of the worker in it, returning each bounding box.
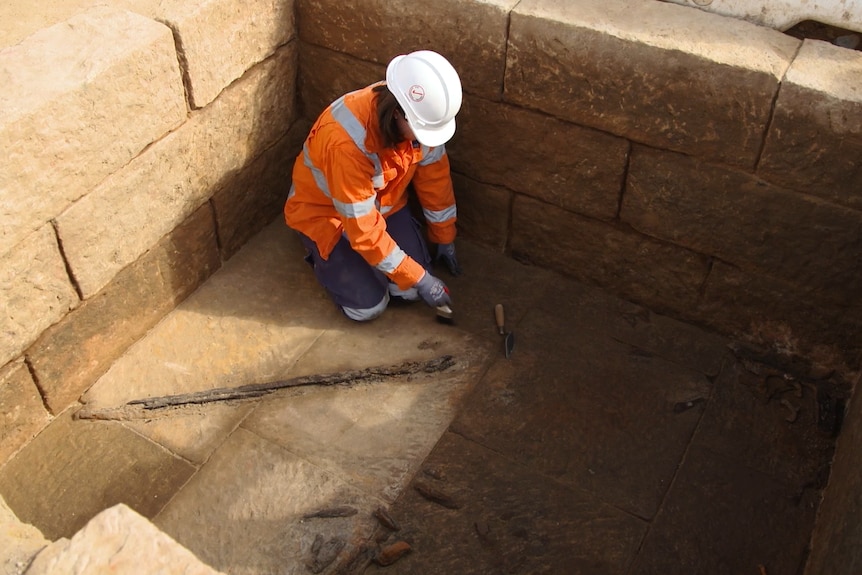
[298,0,862,377]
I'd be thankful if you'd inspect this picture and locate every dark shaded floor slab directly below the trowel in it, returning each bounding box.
[452,311,711,518]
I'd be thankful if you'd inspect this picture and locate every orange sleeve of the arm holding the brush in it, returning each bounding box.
[324,142,425,289]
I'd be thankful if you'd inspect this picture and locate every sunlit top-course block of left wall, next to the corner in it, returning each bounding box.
[157,0,296,108]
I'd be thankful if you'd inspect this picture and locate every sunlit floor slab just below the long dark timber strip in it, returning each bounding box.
[243,346,492,502]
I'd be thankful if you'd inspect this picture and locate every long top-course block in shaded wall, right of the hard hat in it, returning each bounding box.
[504,0,799,168]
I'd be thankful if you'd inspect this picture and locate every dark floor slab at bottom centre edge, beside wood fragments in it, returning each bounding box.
[365,433,646,575]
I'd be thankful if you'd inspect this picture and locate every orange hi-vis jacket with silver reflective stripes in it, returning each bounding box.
[284,82,456,289]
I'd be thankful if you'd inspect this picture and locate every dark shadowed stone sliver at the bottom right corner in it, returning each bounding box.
[805,368,862,575]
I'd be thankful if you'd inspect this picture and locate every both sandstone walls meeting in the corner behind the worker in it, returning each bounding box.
[0,0,862,568]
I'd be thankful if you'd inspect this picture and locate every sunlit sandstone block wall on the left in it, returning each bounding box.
[0,0,304,464]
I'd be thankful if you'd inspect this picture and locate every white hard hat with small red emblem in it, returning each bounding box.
[386,50,461,147]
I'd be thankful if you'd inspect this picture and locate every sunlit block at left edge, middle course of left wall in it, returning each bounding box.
[0,224,78,365]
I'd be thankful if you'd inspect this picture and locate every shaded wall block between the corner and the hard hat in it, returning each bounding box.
[299,43,386,122]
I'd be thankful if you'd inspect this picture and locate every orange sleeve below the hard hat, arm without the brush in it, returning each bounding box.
[413,146,458,244]
